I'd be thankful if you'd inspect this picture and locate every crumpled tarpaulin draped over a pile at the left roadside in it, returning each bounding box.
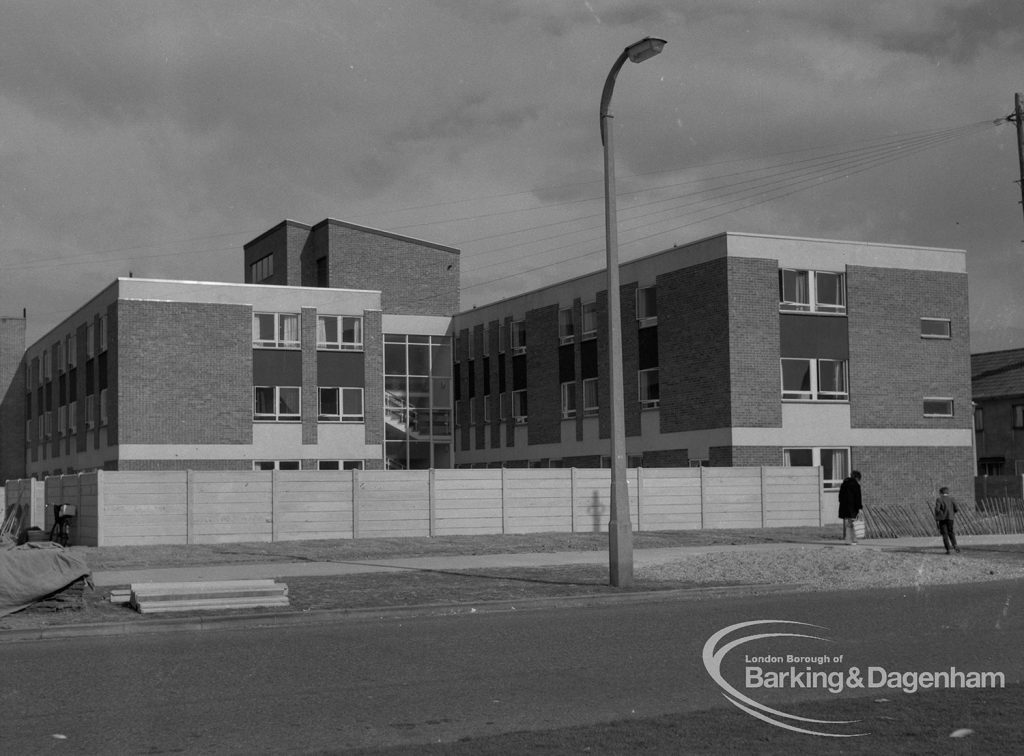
[0,543,92,617]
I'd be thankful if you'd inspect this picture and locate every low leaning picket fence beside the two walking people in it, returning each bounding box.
[863,497,1024,538]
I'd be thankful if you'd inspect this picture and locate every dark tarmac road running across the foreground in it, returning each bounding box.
[0,582,1024,754]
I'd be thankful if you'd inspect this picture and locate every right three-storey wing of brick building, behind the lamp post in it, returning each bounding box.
[453,234,973,510]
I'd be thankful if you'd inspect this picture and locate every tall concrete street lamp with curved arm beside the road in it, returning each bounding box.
[601,37,665,588]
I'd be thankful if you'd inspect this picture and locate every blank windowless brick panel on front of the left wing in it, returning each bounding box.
[115,300,253,442]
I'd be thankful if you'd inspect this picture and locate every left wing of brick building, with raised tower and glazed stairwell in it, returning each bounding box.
[12,219,459,477]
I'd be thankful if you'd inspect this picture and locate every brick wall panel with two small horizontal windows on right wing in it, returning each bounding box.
[847,265,973,428]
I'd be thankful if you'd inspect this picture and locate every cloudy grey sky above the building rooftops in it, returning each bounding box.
[6,0,1024,351]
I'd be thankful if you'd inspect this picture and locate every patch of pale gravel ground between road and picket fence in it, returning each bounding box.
[636,546,1024,591]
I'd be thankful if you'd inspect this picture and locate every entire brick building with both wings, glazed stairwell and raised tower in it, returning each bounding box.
[0,219,973,502]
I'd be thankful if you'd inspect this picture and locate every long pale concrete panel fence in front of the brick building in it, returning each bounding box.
[5,467,827,546]
